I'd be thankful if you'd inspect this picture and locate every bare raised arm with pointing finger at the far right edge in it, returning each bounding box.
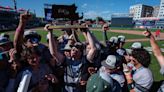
[143,30,164,67]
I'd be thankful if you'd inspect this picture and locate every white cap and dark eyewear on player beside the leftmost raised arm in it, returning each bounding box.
[24,30,41,44]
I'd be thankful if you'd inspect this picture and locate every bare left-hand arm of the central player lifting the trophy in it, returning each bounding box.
[44,24,64,63]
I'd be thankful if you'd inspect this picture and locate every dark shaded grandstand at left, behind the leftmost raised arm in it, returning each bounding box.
[0,9,43,31]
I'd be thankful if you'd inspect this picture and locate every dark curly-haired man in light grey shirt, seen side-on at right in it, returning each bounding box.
[124,49,153,92]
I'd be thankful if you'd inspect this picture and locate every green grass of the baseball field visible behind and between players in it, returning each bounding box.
[1,30,164,81]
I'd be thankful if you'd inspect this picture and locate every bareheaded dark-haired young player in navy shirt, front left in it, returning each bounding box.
[16,48,55,90]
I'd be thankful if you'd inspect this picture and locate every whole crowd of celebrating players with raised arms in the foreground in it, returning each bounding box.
[0,12,164,92]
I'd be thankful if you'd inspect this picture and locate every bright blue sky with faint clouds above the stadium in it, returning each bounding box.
[0,0,160,19]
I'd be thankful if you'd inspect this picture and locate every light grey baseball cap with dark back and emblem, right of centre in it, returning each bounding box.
[101,55,122,69]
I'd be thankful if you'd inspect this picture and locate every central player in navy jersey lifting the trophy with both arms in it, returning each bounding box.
[45,25,96,92]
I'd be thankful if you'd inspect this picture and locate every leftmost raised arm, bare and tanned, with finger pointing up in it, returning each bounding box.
[13,11,31,52]
